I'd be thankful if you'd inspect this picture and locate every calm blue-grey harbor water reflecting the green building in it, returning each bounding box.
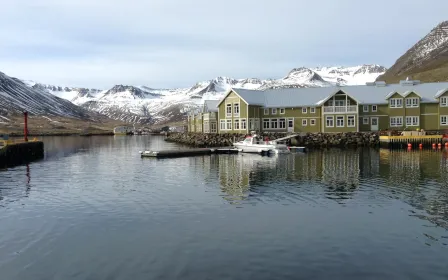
[0,136,448,280]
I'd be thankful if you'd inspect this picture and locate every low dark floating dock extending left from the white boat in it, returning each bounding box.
[140,148,239,158]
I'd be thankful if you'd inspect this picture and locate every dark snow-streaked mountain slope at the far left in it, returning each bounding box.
[0,72,102,120]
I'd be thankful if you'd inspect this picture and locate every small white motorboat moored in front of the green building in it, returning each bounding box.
[233,134,290,154]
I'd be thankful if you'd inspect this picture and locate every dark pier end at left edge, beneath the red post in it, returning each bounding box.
[0,141,44,168]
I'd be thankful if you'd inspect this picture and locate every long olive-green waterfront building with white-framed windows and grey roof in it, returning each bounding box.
[187,80,448,133]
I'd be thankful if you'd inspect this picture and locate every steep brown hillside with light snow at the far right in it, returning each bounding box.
[377,21,448,83]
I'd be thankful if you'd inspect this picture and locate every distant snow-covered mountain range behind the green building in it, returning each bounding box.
[22,65,386,124]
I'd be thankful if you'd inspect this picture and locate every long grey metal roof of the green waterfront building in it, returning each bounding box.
[228,82,448,108]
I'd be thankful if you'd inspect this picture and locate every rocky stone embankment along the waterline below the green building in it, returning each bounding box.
[165,132,379,148]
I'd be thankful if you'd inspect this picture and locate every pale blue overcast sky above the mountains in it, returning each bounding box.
[0,0,448,89]
